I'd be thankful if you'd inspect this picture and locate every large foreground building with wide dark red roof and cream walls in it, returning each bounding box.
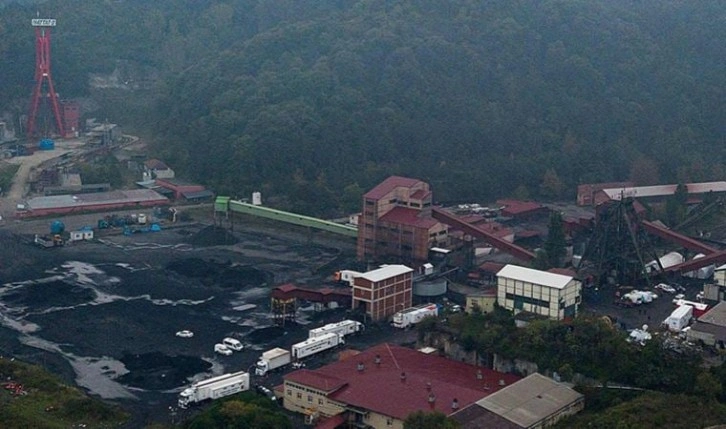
[283,344,520,429]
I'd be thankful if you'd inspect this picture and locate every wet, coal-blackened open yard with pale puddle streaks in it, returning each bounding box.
[0,219,411,427]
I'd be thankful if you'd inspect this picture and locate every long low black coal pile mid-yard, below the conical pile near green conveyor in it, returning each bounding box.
[167,258,272,288]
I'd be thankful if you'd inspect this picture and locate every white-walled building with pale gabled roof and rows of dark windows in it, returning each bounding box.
[497,265,582,320]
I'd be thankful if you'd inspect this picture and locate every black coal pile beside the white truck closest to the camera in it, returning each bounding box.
[117,352,212,390]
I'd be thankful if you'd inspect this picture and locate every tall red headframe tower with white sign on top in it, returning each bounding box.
[28,18,65,138]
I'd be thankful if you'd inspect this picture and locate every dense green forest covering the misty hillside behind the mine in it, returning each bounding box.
[0,0,726,214]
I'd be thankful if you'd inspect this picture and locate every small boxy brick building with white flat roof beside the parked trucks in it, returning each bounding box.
[352,265,413,321]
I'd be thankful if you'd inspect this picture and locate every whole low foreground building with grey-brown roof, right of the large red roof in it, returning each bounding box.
[452,373,585,429]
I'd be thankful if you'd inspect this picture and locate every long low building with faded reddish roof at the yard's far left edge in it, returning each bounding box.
[17,189,169,217]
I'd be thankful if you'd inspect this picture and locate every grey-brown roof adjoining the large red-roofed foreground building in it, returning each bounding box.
[477,373,583,428]
